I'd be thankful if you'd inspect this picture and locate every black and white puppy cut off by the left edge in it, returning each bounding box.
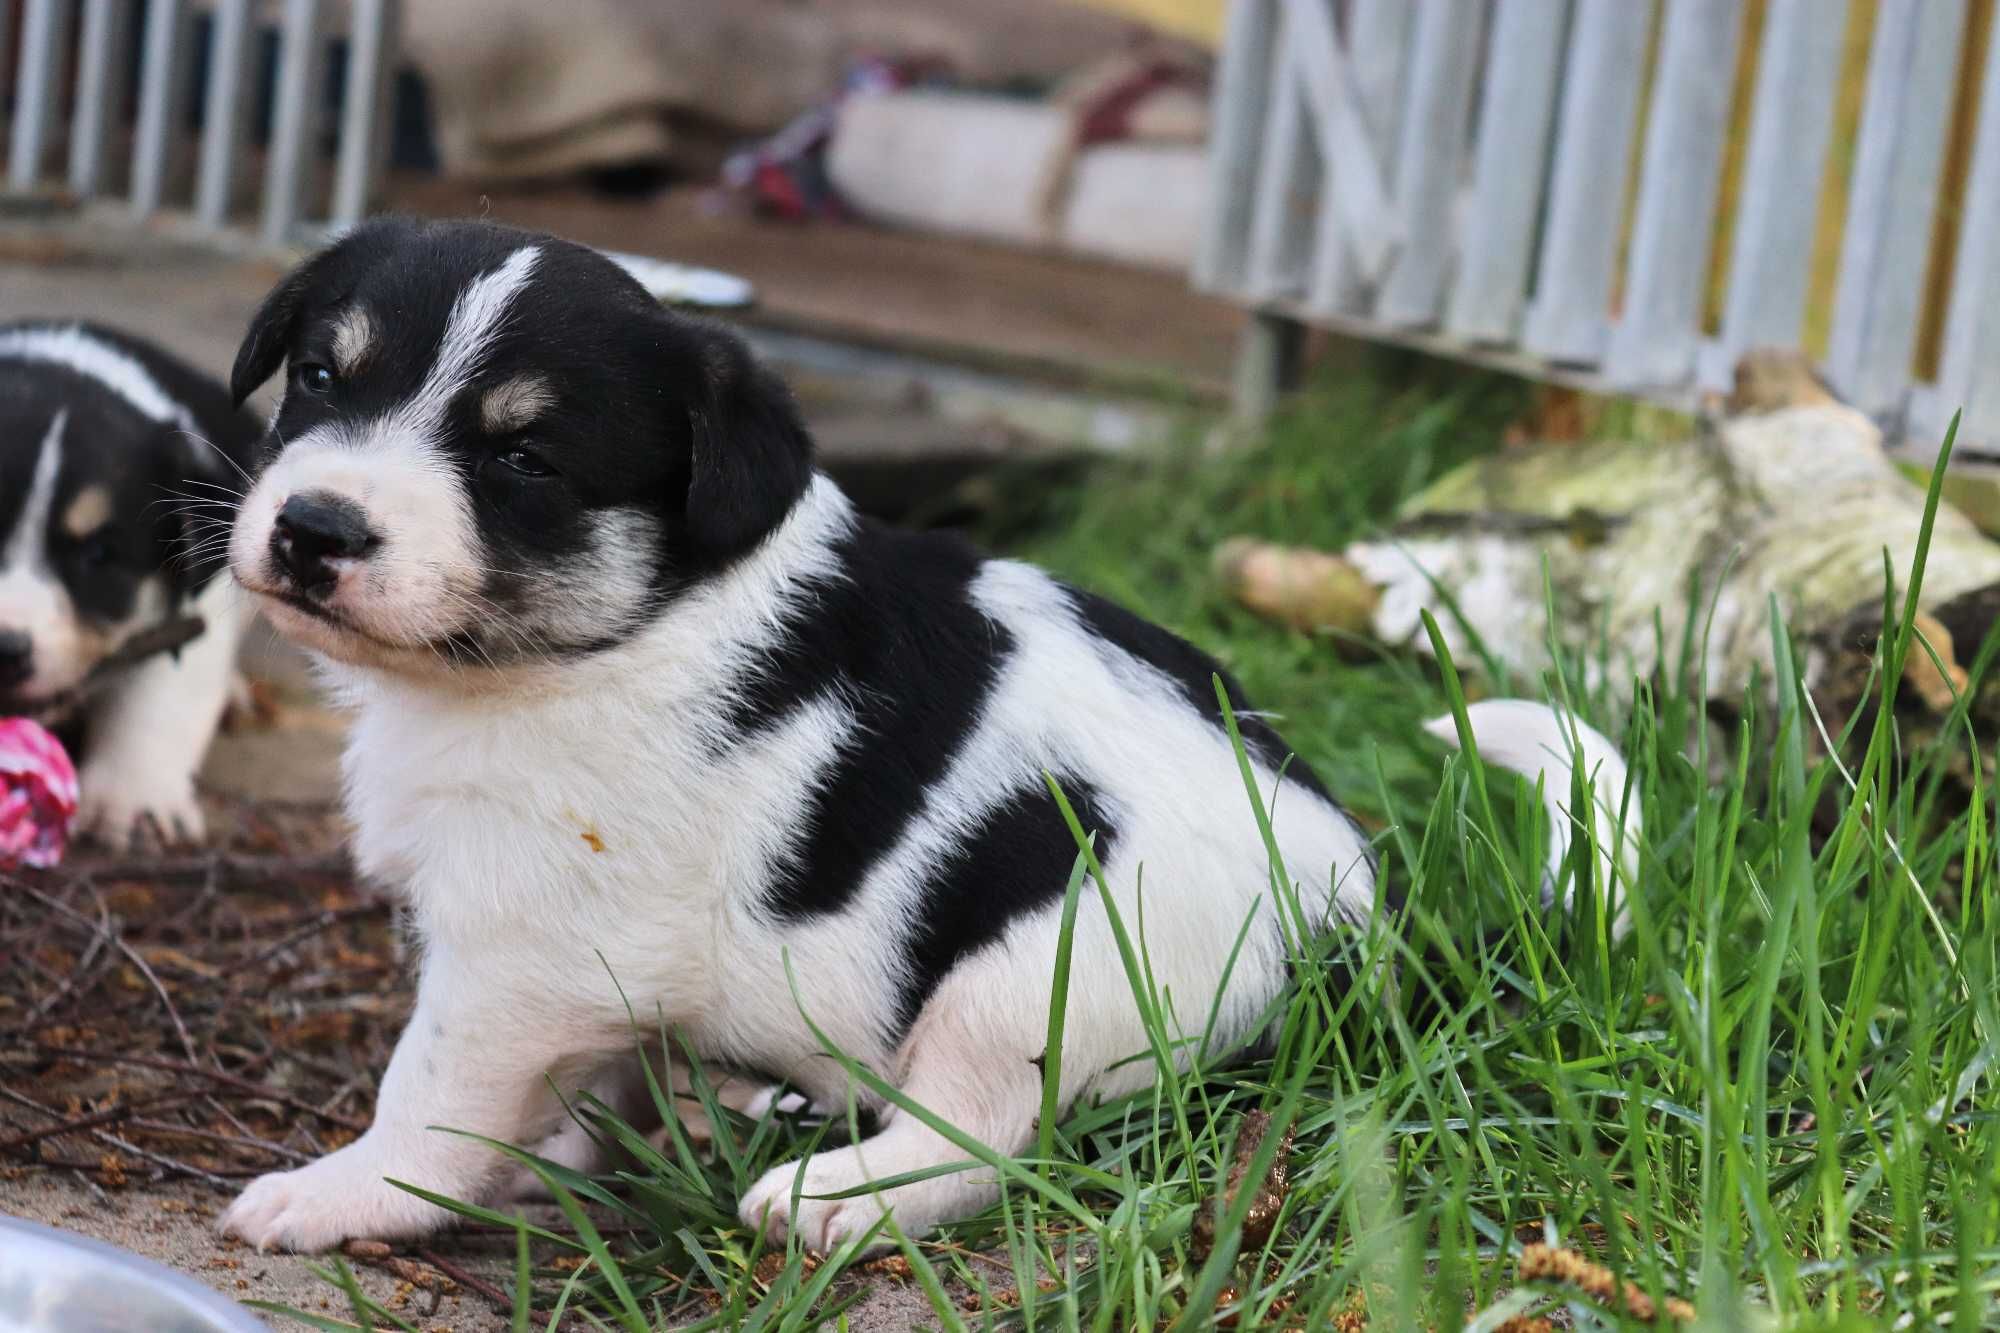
[0,322,264,845]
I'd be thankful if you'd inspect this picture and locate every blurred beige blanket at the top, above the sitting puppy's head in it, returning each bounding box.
[402,0,1160,180]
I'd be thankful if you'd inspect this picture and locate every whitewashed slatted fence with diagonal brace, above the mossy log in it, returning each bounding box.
[1196,0,2000,446]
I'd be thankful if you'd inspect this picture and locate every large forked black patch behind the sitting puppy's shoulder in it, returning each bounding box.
[728,522,1014,919]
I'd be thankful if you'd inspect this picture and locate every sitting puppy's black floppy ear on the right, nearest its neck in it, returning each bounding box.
[686,328,812,560]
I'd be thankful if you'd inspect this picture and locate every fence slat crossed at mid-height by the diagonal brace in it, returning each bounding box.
[1312,0,1416,312]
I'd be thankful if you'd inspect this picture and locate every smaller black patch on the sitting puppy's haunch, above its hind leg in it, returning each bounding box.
[894,777,1118,1032]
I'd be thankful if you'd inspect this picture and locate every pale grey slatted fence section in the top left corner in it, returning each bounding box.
[0,0,396,244]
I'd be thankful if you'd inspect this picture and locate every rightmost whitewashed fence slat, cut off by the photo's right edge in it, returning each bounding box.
[1920,7,2000,446]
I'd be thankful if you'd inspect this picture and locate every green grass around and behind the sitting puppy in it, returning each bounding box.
[278,366,2000,1333]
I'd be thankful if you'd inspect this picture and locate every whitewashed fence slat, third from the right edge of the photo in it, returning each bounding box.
[1704,0,1848,378]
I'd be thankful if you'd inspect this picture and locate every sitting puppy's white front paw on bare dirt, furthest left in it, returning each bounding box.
[216,1147,450,1253]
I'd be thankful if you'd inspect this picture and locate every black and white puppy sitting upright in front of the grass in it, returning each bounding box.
[222,220,1622,1249]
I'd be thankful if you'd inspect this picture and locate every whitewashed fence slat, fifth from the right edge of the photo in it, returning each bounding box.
[1522,0,1652,364]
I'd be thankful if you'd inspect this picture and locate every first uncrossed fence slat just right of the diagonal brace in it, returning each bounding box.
[1376,0,1484,326]
